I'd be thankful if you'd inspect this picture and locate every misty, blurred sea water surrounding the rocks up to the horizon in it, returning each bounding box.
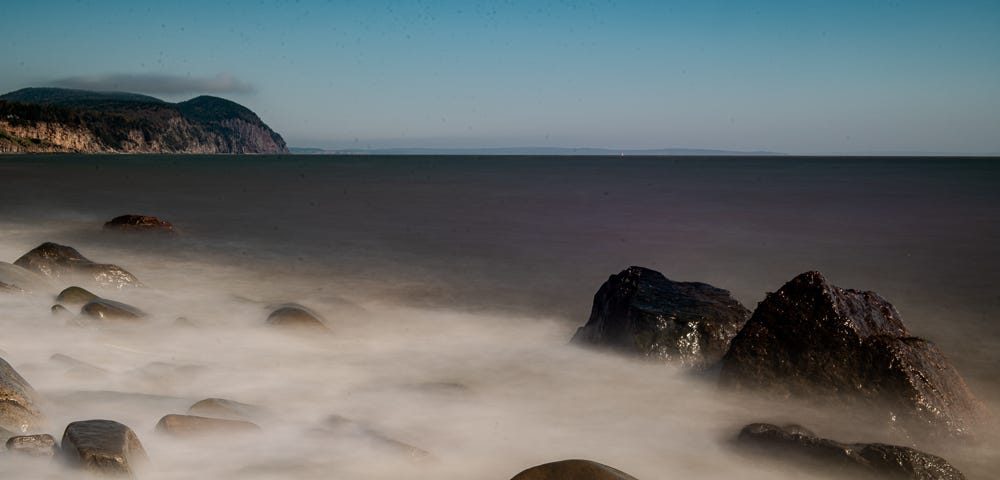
[0,155,1000,480]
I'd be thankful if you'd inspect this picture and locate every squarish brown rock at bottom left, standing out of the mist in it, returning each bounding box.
[62,420,149,476]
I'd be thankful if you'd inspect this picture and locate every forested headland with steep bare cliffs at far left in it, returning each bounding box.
[0,88,288,153]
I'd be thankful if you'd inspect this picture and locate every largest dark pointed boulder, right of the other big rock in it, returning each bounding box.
[720,272,988,436]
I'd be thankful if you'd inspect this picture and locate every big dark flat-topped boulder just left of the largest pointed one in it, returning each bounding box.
[572,267,750,368]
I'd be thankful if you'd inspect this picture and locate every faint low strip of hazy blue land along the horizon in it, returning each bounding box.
[289,147,784,156]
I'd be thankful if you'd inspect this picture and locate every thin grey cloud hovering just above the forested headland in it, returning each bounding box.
[52,73,256,95]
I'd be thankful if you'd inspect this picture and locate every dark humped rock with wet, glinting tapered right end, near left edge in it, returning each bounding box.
[14,242,142,288]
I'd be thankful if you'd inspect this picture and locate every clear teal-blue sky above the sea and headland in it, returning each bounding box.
[0,0,1000,154]
